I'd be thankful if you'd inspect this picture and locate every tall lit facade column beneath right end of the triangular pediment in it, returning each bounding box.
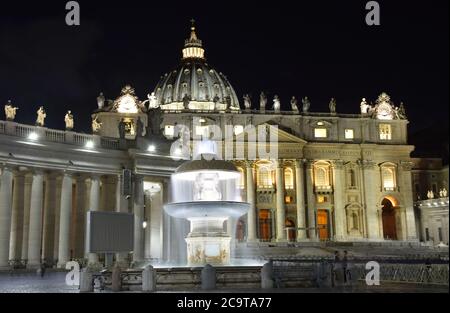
[295,160,306,241]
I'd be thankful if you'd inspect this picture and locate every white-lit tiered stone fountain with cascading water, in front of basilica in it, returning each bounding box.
[164,143,250,266]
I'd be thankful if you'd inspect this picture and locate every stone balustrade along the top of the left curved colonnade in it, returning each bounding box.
[0,121,120,150]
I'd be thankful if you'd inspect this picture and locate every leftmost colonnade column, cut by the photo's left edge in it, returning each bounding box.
[0,167,13,269]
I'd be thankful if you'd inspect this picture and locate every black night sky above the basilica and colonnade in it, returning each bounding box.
[0,0,449,156]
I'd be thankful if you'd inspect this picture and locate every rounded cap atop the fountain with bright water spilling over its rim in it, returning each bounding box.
[174,158,240,181]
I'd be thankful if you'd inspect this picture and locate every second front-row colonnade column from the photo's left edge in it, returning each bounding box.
[27,170,44,268]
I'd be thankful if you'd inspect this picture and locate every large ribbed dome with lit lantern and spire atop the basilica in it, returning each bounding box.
[154,22,239,111]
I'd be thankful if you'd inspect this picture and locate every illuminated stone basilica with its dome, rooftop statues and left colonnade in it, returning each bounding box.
[0,23,432,268]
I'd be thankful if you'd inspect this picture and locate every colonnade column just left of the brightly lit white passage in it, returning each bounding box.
[133,176,144,262]
